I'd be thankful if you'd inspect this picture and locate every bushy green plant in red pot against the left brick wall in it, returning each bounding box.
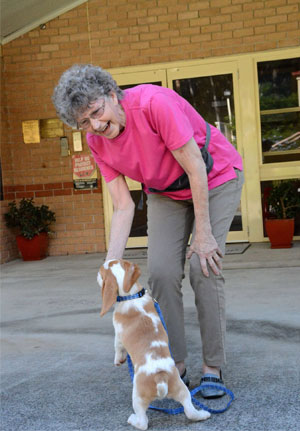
[4,198,56,260]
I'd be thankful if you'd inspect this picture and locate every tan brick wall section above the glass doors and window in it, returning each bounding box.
[88,0,300,68]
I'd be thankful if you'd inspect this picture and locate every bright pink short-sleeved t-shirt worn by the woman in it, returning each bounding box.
[87,84,242,200]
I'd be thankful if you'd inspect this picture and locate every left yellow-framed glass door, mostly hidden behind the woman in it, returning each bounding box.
[102,70,167,248]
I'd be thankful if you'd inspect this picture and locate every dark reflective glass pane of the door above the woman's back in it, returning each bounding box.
[173,74,236,147]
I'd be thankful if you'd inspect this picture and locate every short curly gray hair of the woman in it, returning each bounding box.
[52,64,123,127]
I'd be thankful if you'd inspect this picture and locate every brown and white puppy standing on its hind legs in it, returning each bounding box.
[97,259,210,430]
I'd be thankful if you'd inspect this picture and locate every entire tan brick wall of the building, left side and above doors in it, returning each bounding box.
[1,0,300,262]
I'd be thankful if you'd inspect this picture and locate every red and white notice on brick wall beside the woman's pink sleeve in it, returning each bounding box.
[72,155,97,190]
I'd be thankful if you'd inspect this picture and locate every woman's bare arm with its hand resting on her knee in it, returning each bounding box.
[172,138,222,277]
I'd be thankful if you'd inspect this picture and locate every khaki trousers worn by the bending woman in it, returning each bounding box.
[148,170,244,367]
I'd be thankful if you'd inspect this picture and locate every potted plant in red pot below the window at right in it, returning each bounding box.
[265,180,300,248]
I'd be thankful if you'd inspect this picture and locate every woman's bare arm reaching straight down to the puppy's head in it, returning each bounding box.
[106,175,135,260]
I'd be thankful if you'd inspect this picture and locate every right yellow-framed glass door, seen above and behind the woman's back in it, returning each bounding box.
[167,62,248,241]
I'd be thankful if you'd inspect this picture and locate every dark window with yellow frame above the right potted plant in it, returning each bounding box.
[257,58,300,163]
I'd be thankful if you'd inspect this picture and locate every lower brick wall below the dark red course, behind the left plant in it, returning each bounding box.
[0,192,105,263]
